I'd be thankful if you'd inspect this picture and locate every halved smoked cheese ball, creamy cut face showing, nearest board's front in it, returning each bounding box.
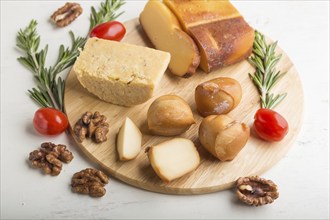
[147,138,200,183]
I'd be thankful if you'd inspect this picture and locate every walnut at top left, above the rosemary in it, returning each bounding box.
[50,2,83,27]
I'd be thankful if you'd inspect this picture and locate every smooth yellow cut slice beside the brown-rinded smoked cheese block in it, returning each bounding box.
[140,0,200,76]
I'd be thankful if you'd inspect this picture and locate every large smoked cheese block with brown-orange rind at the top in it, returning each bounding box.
[164,0,254,72]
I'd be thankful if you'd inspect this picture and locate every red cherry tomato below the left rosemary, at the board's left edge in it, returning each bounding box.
[33,108,69,135]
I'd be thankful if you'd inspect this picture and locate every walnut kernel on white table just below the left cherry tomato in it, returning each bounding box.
[29,142,73,176]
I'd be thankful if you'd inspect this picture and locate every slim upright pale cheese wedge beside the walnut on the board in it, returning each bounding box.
[117,117,142,161]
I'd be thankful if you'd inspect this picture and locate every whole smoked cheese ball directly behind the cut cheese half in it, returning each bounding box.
[147,95,195,136]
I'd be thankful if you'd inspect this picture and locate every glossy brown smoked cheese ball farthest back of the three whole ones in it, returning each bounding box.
[195,77,242,117]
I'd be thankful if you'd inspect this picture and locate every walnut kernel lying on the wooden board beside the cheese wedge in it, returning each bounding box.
[73,111,109,143]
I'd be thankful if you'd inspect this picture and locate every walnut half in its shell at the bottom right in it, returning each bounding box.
[236,176,279,206]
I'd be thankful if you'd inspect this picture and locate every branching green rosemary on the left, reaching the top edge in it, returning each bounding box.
[16,0,125,111]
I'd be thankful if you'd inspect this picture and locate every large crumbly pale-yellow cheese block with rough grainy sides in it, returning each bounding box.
[73,38,171,106]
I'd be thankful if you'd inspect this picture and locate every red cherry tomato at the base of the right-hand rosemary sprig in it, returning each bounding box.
[253,108,289,141]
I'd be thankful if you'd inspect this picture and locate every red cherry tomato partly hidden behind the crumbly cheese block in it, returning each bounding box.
[90,21,126,41]
